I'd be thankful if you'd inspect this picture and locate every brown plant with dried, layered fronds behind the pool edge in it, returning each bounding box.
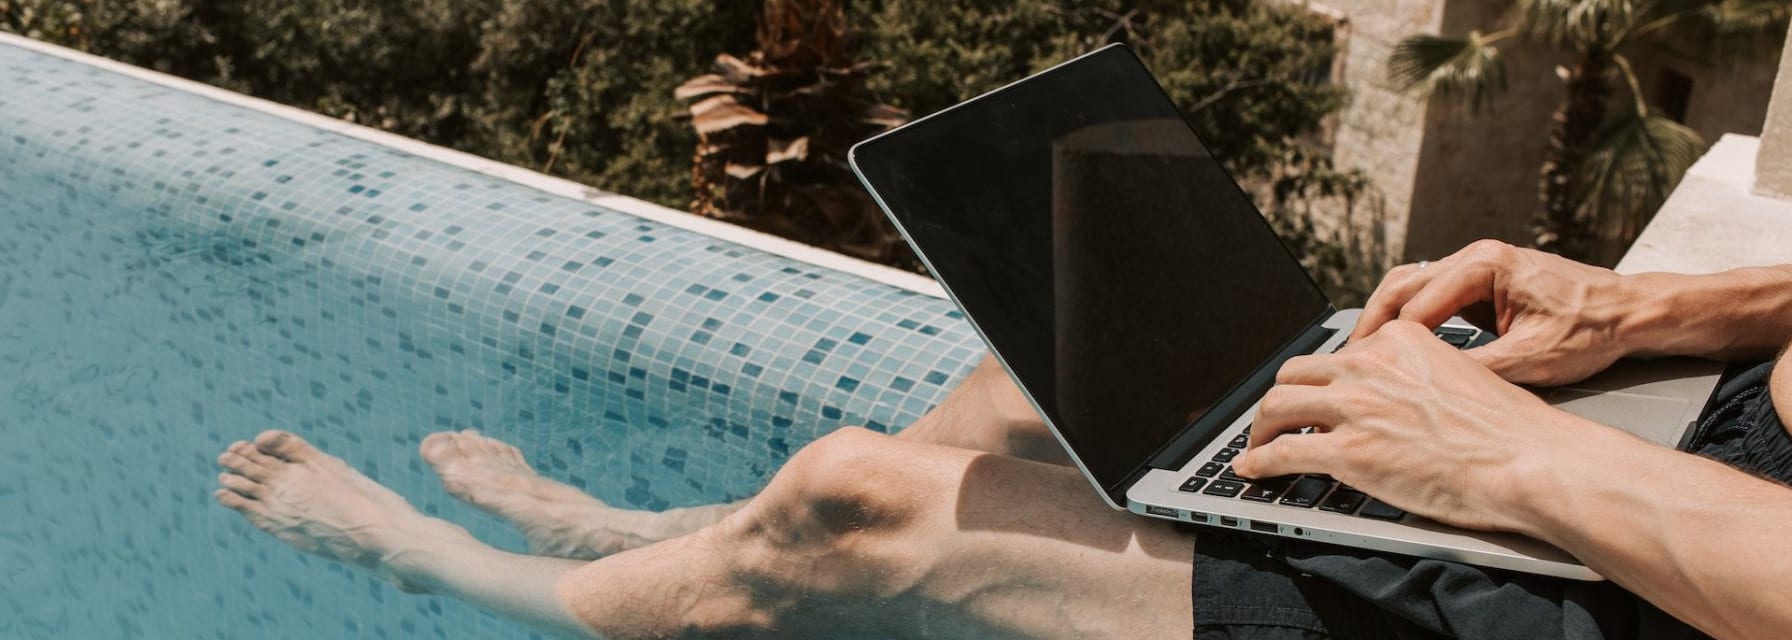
[674,0,919,263]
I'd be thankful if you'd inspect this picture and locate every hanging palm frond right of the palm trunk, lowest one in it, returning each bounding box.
[1577,109,1704,240]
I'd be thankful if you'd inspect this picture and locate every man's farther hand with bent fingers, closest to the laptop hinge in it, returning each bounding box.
[1351,240,1641,385]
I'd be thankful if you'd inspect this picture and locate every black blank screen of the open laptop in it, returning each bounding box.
[853,47,1330,493]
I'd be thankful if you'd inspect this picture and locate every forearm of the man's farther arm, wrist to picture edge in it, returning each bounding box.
[1622,265,1792,360]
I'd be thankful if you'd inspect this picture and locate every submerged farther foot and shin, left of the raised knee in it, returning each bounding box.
[421,428,738,559]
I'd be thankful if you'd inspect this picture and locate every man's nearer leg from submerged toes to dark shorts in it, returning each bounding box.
[217,428,1193,638]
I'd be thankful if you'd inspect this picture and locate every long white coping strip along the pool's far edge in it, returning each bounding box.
[0,32,946,298]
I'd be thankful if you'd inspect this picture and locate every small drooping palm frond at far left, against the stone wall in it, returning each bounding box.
[1387,32,1505,111]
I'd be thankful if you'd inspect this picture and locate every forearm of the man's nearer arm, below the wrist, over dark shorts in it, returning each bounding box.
[1523,423,1792,638]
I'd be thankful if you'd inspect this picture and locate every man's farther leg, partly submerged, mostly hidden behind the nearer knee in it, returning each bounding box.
[421,357,1070,559]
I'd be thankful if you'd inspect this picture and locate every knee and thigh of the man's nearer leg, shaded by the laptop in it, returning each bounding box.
[744,430,1193,638]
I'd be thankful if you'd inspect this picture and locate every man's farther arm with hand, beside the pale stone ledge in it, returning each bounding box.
[1351,240,1792,385]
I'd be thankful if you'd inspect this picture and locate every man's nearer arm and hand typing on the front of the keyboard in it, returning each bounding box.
[1233,321,1792,638]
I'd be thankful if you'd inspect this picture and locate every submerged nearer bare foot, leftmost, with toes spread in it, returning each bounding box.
[213,430,477,592]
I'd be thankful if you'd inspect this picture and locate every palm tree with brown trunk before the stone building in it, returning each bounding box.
[1387,0,1792,262]
